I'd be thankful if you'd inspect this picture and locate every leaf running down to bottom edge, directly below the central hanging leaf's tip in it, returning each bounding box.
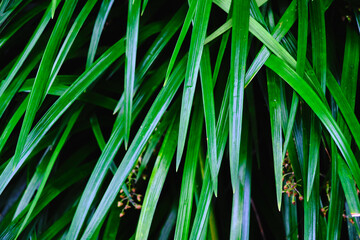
[174,98,204,240]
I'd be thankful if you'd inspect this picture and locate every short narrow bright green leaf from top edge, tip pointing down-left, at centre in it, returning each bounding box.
[164,1,195,85]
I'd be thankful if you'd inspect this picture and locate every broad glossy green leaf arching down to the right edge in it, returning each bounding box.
[266,55,360,192]
